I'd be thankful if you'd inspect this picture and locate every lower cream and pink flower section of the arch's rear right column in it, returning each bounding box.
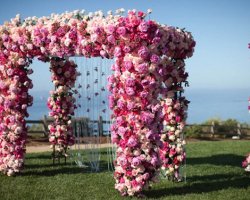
[160,98,188,181]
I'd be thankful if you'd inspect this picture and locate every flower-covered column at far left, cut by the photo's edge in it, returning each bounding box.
[0,52,33,176]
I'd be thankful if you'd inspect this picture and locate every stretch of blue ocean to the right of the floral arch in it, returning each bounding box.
[185,88,250,123]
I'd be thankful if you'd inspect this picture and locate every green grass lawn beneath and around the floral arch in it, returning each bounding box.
[0,141,250,200]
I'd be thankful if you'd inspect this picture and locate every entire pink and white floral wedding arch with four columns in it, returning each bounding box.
[0,10,195,195]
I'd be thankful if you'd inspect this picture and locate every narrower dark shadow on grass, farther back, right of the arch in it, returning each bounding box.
[187,154,244,167]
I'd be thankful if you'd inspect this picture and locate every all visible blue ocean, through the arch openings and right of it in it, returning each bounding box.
[28,88,250,123]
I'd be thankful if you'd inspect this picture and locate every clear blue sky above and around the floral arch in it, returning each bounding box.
[0,0,250,91]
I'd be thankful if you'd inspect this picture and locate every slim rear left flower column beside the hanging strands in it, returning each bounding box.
[48,58,78,161]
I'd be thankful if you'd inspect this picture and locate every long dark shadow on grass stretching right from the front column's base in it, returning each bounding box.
[145,174,250,199]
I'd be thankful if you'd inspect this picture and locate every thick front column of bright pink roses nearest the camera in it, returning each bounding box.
[108,46,161,196]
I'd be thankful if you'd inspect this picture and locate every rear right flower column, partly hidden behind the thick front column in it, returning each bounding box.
[160,59,189,181]
